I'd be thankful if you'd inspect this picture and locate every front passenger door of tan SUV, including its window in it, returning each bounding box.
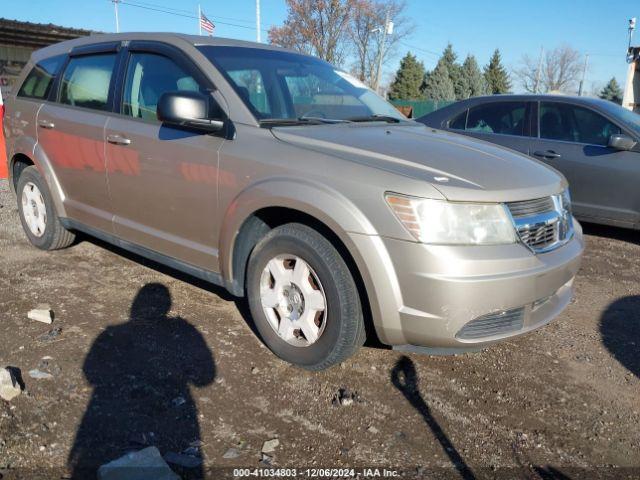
[105,42,224,271]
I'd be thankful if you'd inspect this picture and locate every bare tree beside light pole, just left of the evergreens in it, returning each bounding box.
[349,0,414,85]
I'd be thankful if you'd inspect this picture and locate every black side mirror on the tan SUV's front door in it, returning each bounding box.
[156,91,224,132]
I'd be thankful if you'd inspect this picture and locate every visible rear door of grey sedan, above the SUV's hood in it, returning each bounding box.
[449,101,532,154]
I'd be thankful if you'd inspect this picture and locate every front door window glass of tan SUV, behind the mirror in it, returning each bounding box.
[122,53,201,120]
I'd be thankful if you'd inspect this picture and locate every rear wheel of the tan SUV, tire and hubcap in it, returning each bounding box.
[17,166,75,250]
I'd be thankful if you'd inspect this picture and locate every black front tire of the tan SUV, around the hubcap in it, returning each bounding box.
[247,223,366,370]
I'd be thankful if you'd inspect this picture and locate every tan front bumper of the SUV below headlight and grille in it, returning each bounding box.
[350,220,584,351]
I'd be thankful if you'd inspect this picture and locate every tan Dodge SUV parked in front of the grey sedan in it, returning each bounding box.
[6,33,583,370]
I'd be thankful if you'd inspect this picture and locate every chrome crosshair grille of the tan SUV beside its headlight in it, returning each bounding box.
[507,195,573,253]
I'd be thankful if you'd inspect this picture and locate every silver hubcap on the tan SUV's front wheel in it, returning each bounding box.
[260,254,327,347]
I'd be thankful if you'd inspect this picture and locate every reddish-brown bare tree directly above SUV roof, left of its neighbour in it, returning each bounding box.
[269,0,354,64]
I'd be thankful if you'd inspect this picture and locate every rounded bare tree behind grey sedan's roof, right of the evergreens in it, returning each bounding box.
[514,45,582,93]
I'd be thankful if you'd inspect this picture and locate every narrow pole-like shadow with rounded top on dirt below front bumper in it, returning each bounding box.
[391,355,476,479]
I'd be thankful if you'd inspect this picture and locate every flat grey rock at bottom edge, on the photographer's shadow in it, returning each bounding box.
[98,447,180,480]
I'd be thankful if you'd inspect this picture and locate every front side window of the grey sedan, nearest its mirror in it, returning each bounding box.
[540,102,620,145]
